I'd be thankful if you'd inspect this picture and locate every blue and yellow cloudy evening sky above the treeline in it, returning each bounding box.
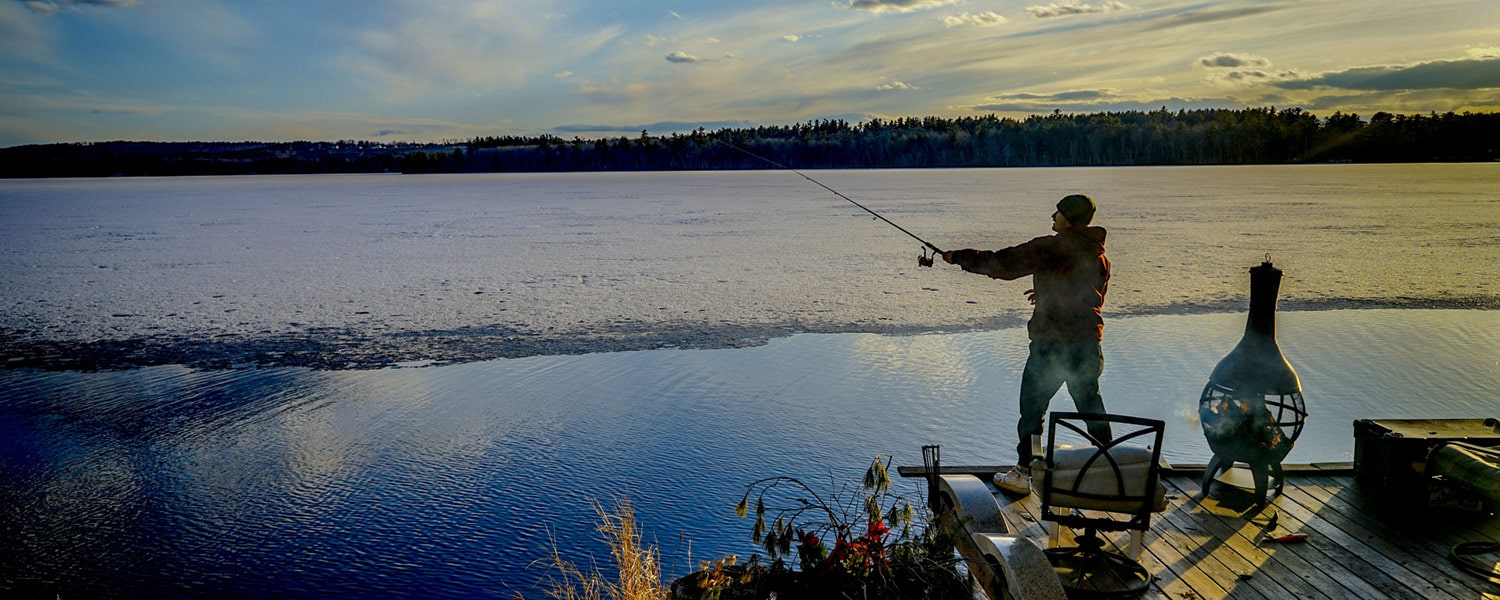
[0,0,1500,147]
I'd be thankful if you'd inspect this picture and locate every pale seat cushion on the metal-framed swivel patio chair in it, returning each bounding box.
[1050,446,1167,513]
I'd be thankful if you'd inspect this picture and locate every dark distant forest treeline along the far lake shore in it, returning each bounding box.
[0,108,1500,177]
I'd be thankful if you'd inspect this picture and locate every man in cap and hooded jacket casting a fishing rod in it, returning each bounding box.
[942,194,1112,495]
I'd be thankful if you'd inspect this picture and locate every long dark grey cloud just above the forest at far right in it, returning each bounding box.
[1278,57,1500,92]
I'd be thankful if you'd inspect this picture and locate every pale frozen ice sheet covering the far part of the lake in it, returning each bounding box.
[0,164,1500,368]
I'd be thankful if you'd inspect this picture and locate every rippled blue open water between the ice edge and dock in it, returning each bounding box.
[0,311,1500,597]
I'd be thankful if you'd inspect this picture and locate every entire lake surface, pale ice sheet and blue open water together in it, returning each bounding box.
[0,165,1500,599]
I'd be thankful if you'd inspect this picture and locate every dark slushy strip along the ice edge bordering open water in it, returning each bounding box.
[0,296,1500,372]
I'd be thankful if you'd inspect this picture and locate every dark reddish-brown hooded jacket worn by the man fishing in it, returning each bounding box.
[953,227,1110,342]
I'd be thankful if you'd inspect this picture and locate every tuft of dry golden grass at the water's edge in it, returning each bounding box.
[531,500,672,600]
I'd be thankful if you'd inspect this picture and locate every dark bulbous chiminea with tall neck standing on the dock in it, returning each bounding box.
[1199,257,1307,504]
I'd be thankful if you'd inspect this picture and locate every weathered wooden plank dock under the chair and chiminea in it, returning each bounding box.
[899,464,1500,600]
